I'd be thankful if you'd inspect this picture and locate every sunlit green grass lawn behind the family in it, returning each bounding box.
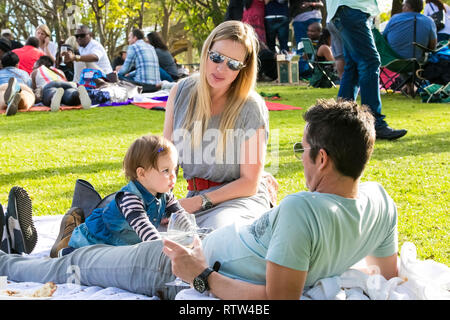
[0,84,450,266]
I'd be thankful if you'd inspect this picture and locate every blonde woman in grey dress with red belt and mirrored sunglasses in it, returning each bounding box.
[164,21,276,229]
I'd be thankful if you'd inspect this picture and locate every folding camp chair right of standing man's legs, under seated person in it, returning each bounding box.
[372,28,423,98]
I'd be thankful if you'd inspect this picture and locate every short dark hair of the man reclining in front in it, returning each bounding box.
[303,99,375,180]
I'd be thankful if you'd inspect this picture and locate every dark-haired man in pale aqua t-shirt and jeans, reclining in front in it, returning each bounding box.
[0,100,398,299]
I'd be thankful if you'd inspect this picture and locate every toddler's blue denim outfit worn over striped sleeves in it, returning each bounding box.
[69,181,166,248]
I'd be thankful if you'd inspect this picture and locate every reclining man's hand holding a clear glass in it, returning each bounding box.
[163,235,208,284]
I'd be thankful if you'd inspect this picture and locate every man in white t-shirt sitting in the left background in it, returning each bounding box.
[63,26,113,82]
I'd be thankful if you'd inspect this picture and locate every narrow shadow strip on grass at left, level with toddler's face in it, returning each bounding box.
[0,162,122,186]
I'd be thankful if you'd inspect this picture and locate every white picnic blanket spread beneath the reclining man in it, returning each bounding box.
[1,215,450,300]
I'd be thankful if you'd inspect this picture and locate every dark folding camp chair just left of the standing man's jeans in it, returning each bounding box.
[302,38,336,88]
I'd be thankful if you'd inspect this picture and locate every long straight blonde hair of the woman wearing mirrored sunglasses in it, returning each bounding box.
[183,20,259,154]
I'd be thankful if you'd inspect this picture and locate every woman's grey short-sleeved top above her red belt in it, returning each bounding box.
[173,76,269,183]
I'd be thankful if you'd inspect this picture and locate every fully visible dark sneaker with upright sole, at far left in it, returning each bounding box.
[6,187,37,254]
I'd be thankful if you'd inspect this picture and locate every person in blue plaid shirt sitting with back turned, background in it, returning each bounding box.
[118,29,161,85]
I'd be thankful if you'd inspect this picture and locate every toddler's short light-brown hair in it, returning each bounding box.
[123,135,176,181]
